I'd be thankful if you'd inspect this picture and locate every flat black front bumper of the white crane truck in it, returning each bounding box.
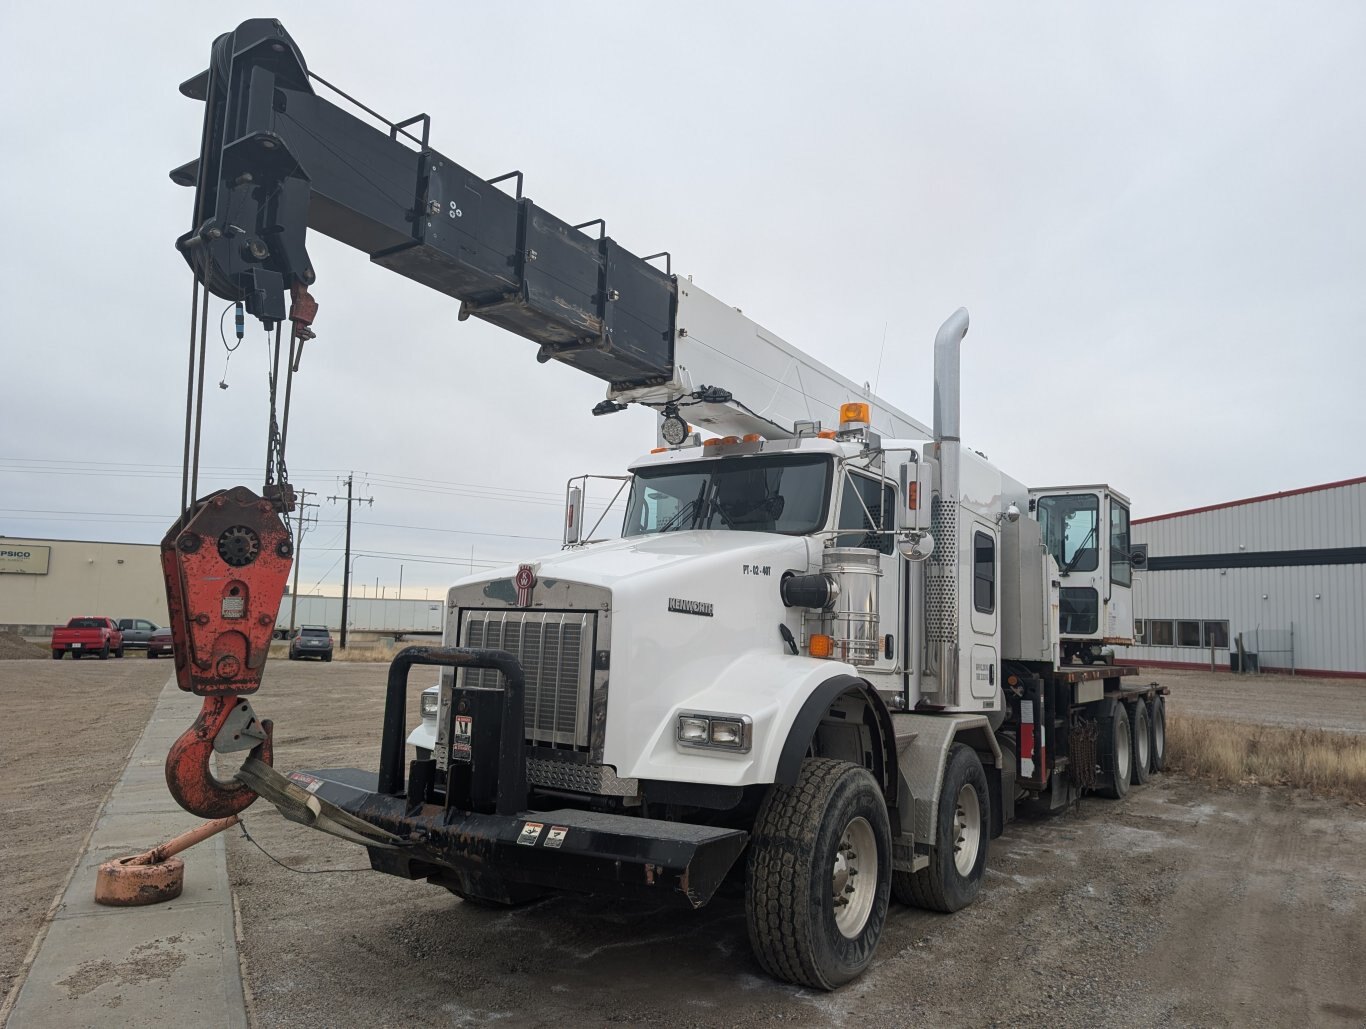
[281,768,749,907]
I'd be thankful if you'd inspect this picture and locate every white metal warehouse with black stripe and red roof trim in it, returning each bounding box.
[1117,476,1366,678]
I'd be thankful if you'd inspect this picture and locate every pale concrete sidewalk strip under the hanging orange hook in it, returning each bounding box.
[5,678,247,1029]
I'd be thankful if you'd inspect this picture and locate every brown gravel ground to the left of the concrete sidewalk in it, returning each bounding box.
[0,652,169,998]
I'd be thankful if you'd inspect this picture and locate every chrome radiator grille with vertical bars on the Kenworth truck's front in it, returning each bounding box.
[460,609,594,747]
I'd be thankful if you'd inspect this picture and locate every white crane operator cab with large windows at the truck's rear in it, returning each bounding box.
[1030,485,1142,664]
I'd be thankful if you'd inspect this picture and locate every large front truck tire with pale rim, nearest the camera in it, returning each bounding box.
[744,757,892,989]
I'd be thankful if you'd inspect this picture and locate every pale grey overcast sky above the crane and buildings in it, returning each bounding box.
[0,0,1366,596]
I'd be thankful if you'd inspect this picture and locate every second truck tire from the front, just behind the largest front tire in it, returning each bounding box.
[892,743,992,911]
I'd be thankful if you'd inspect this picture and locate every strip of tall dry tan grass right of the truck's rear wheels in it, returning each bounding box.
[1167,711,1366,804]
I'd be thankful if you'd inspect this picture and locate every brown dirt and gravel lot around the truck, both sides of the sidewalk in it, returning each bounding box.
[0,659,1366,1026]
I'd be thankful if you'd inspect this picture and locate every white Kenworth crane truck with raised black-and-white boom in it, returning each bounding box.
[159,19,1164,989]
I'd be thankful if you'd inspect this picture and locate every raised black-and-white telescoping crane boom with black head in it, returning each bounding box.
[171,19,928,439]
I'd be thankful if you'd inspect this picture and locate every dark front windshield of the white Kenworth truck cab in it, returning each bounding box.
[622,454,833,536]
